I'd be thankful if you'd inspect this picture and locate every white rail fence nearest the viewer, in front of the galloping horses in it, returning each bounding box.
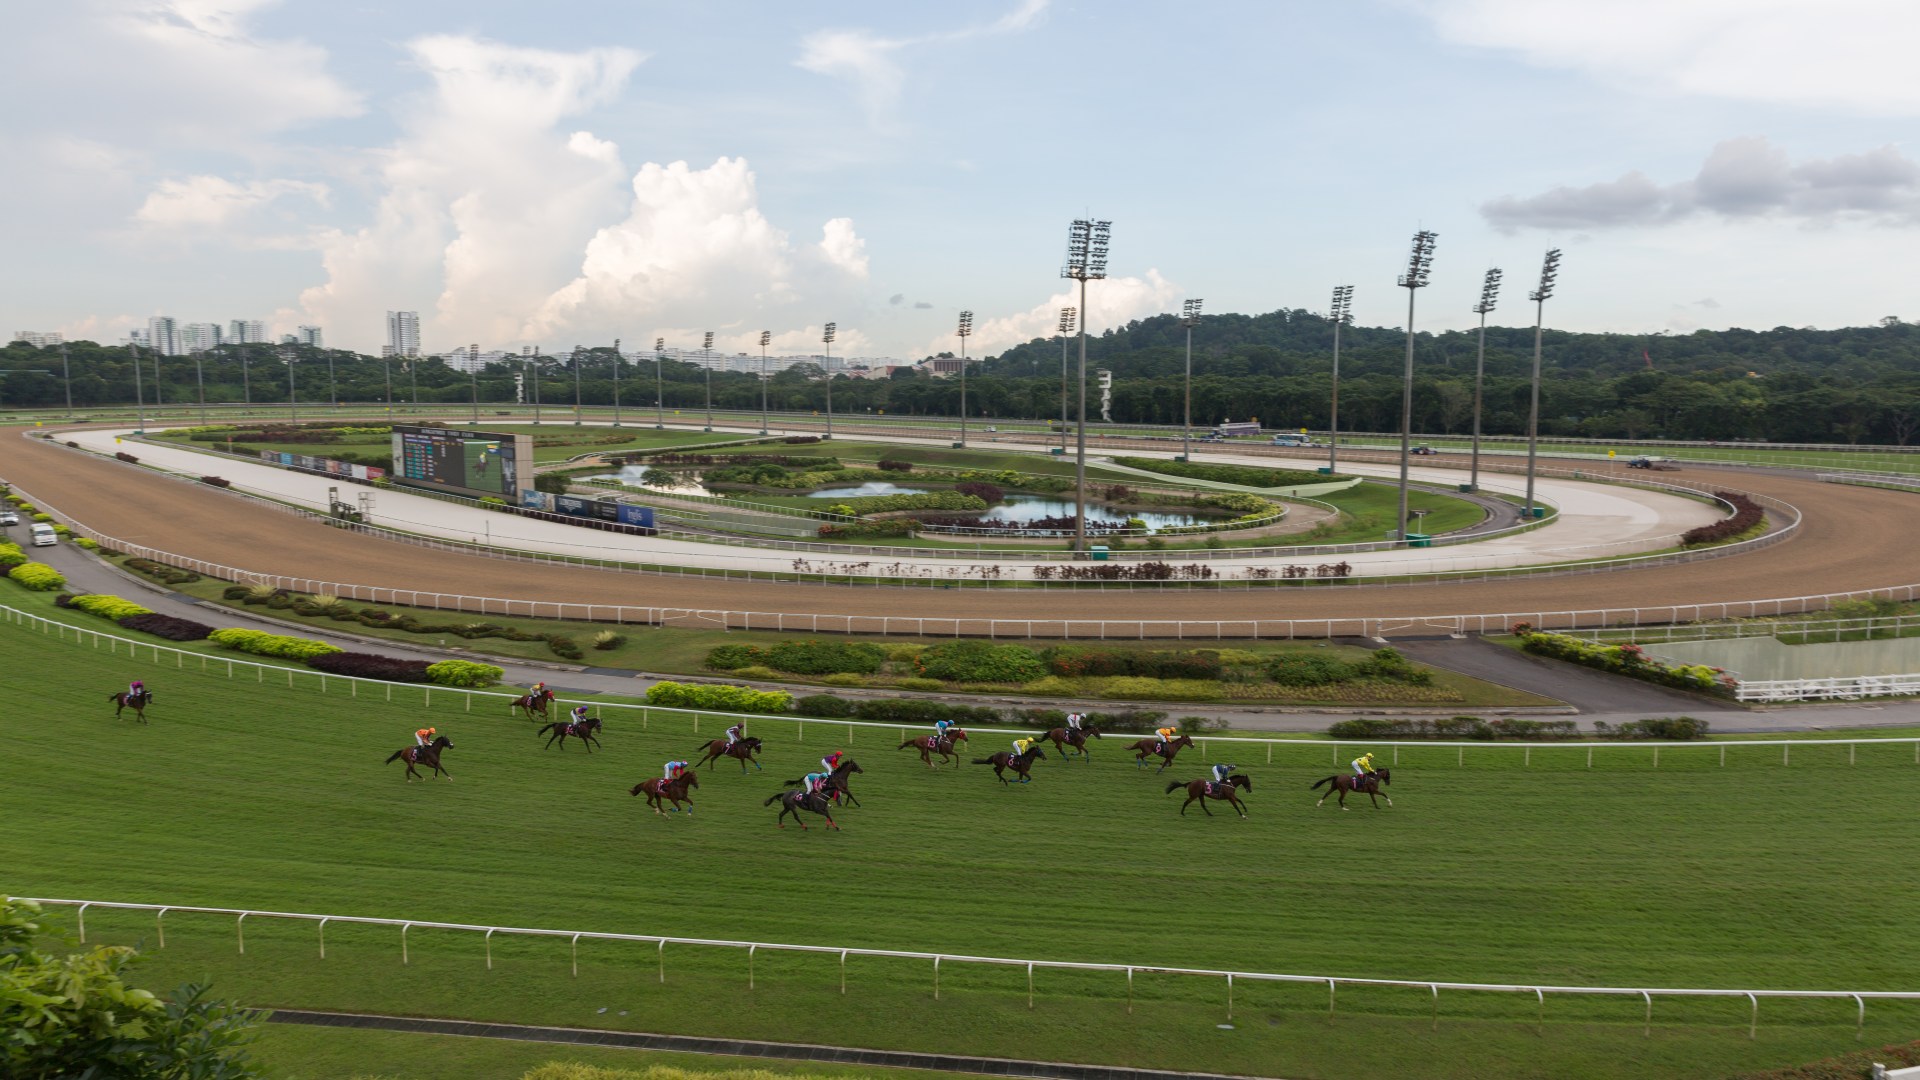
[23,897,1920,1038]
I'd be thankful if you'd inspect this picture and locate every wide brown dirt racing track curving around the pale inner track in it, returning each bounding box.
[0,429,1920,638]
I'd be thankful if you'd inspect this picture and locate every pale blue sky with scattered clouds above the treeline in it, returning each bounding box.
[0,0,1920,357]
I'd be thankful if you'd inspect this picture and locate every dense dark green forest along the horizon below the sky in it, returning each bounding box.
[15,309,1920,446]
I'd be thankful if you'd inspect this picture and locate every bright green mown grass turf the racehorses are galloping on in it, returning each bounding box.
[0,630,1920,1076]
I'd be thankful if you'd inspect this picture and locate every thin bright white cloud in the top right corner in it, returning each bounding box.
[1411,0,1920,115]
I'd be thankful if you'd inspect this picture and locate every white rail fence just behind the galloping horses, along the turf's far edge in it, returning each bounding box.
[15,605,1920,769]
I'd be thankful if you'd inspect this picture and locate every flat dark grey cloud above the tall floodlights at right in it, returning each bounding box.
[1480,136,1920,233]
